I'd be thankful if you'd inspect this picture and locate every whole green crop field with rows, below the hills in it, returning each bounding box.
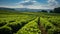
[0,10,60,34]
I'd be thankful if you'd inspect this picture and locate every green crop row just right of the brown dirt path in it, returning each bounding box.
[40,17,60,34]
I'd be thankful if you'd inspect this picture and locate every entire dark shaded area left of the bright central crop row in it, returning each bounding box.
[0,18,35,34]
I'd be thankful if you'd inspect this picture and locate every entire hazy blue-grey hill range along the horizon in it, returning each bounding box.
[0,7,51,12]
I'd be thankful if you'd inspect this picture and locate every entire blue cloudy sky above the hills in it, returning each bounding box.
[0,0,60,9]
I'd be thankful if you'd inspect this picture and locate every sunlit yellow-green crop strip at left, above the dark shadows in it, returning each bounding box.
[0,15,35,26]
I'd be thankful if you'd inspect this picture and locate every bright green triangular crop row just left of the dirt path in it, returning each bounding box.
[16,18,41,34]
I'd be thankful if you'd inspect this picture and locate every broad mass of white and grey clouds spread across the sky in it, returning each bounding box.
[0,0,58,9]
